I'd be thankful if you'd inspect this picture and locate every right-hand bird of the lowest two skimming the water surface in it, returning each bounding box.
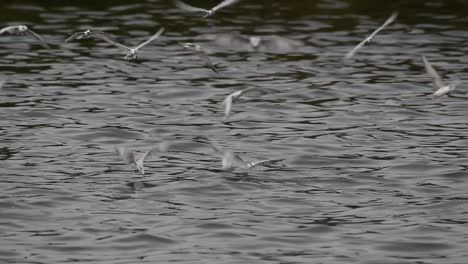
[211,143,281,174]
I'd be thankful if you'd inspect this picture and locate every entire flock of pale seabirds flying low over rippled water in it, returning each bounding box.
[0,0,458,175]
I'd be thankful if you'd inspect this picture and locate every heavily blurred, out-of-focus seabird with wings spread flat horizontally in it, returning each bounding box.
[208,32,303,53]
